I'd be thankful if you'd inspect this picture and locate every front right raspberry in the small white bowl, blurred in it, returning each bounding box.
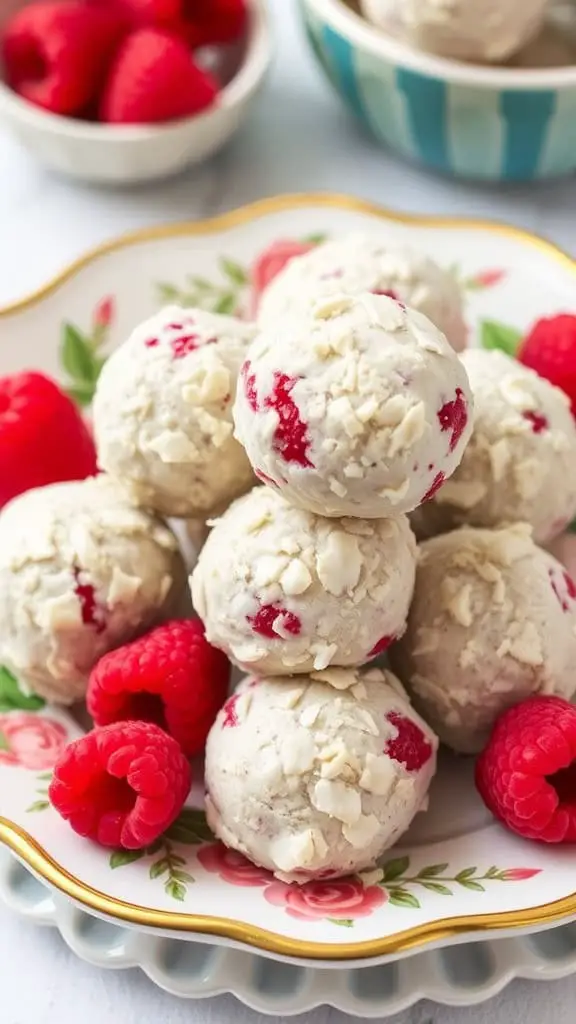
[99,29,218,124]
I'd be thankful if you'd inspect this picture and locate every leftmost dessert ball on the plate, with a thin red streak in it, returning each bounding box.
[0,474,186,703]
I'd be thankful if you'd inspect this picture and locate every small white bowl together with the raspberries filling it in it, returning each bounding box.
[0,0,271,184]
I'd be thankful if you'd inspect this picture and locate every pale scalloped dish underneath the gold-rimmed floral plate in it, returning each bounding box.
[0,850,576,1020]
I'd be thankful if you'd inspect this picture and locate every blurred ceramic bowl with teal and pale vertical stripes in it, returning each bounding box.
[300,0,576,181]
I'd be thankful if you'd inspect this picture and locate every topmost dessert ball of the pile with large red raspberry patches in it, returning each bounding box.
[234,293,472,518]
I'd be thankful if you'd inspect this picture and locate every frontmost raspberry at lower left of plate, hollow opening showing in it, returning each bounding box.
[48,722,192,850]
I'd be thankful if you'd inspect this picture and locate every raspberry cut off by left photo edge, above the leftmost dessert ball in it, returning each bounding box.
[0,373,96,507]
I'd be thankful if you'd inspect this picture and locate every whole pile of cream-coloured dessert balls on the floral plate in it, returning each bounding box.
[0,236,576,883]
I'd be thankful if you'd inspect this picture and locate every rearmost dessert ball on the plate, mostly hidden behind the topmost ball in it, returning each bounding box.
[258,233,466,351]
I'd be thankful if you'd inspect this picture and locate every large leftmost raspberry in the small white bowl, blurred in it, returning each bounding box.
[1,0,125,115]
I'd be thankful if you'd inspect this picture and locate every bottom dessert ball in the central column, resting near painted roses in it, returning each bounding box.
[205,668,438,883]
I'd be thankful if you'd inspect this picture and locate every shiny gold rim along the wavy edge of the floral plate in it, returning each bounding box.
[0,193,576,961]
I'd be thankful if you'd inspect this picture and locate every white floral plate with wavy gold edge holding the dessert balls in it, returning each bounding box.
[0,196,576,967]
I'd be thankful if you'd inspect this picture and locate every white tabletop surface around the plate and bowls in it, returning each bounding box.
[0,0,576,1024]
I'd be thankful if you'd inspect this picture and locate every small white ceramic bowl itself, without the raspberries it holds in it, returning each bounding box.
[0,0,272,184]
